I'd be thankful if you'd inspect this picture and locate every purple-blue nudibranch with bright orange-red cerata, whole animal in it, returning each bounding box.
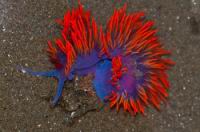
[22,3,174,114]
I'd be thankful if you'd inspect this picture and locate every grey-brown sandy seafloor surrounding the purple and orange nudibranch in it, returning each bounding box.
[0,0,200,132]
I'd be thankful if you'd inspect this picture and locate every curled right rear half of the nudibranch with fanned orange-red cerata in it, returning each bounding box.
[94,4,174,115]
